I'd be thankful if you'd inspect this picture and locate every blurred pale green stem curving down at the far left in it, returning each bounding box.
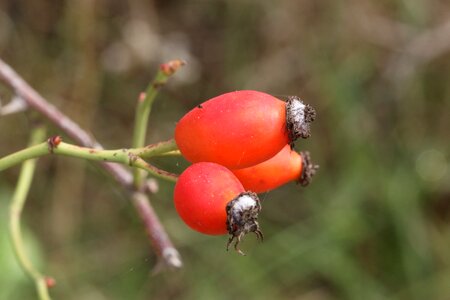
[9,127,50,300]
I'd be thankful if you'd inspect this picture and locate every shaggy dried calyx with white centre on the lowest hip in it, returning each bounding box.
[226,192,263,255]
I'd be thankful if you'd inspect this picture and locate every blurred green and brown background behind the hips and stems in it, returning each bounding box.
[0,0,450,300]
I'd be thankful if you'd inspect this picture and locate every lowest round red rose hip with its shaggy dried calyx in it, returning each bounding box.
[174,162,262,253]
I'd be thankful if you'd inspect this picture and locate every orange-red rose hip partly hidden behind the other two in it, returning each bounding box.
[232,145,318,193]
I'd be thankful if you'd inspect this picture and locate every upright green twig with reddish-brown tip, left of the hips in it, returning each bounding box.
[132,60,185,187]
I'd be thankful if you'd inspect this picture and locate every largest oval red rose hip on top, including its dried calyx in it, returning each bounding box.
[175,91,315,169]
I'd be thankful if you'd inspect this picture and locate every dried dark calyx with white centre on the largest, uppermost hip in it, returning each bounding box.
[286,96,316,147]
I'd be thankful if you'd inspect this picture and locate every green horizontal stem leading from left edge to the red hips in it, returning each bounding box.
[0,142,178,182]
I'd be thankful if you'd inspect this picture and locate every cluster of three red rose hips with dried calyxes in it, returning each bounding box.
[174,91,317,254]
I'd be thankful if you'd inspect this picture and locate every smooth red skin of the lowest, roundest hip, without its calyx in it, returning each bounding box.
[174,162,245,235]
